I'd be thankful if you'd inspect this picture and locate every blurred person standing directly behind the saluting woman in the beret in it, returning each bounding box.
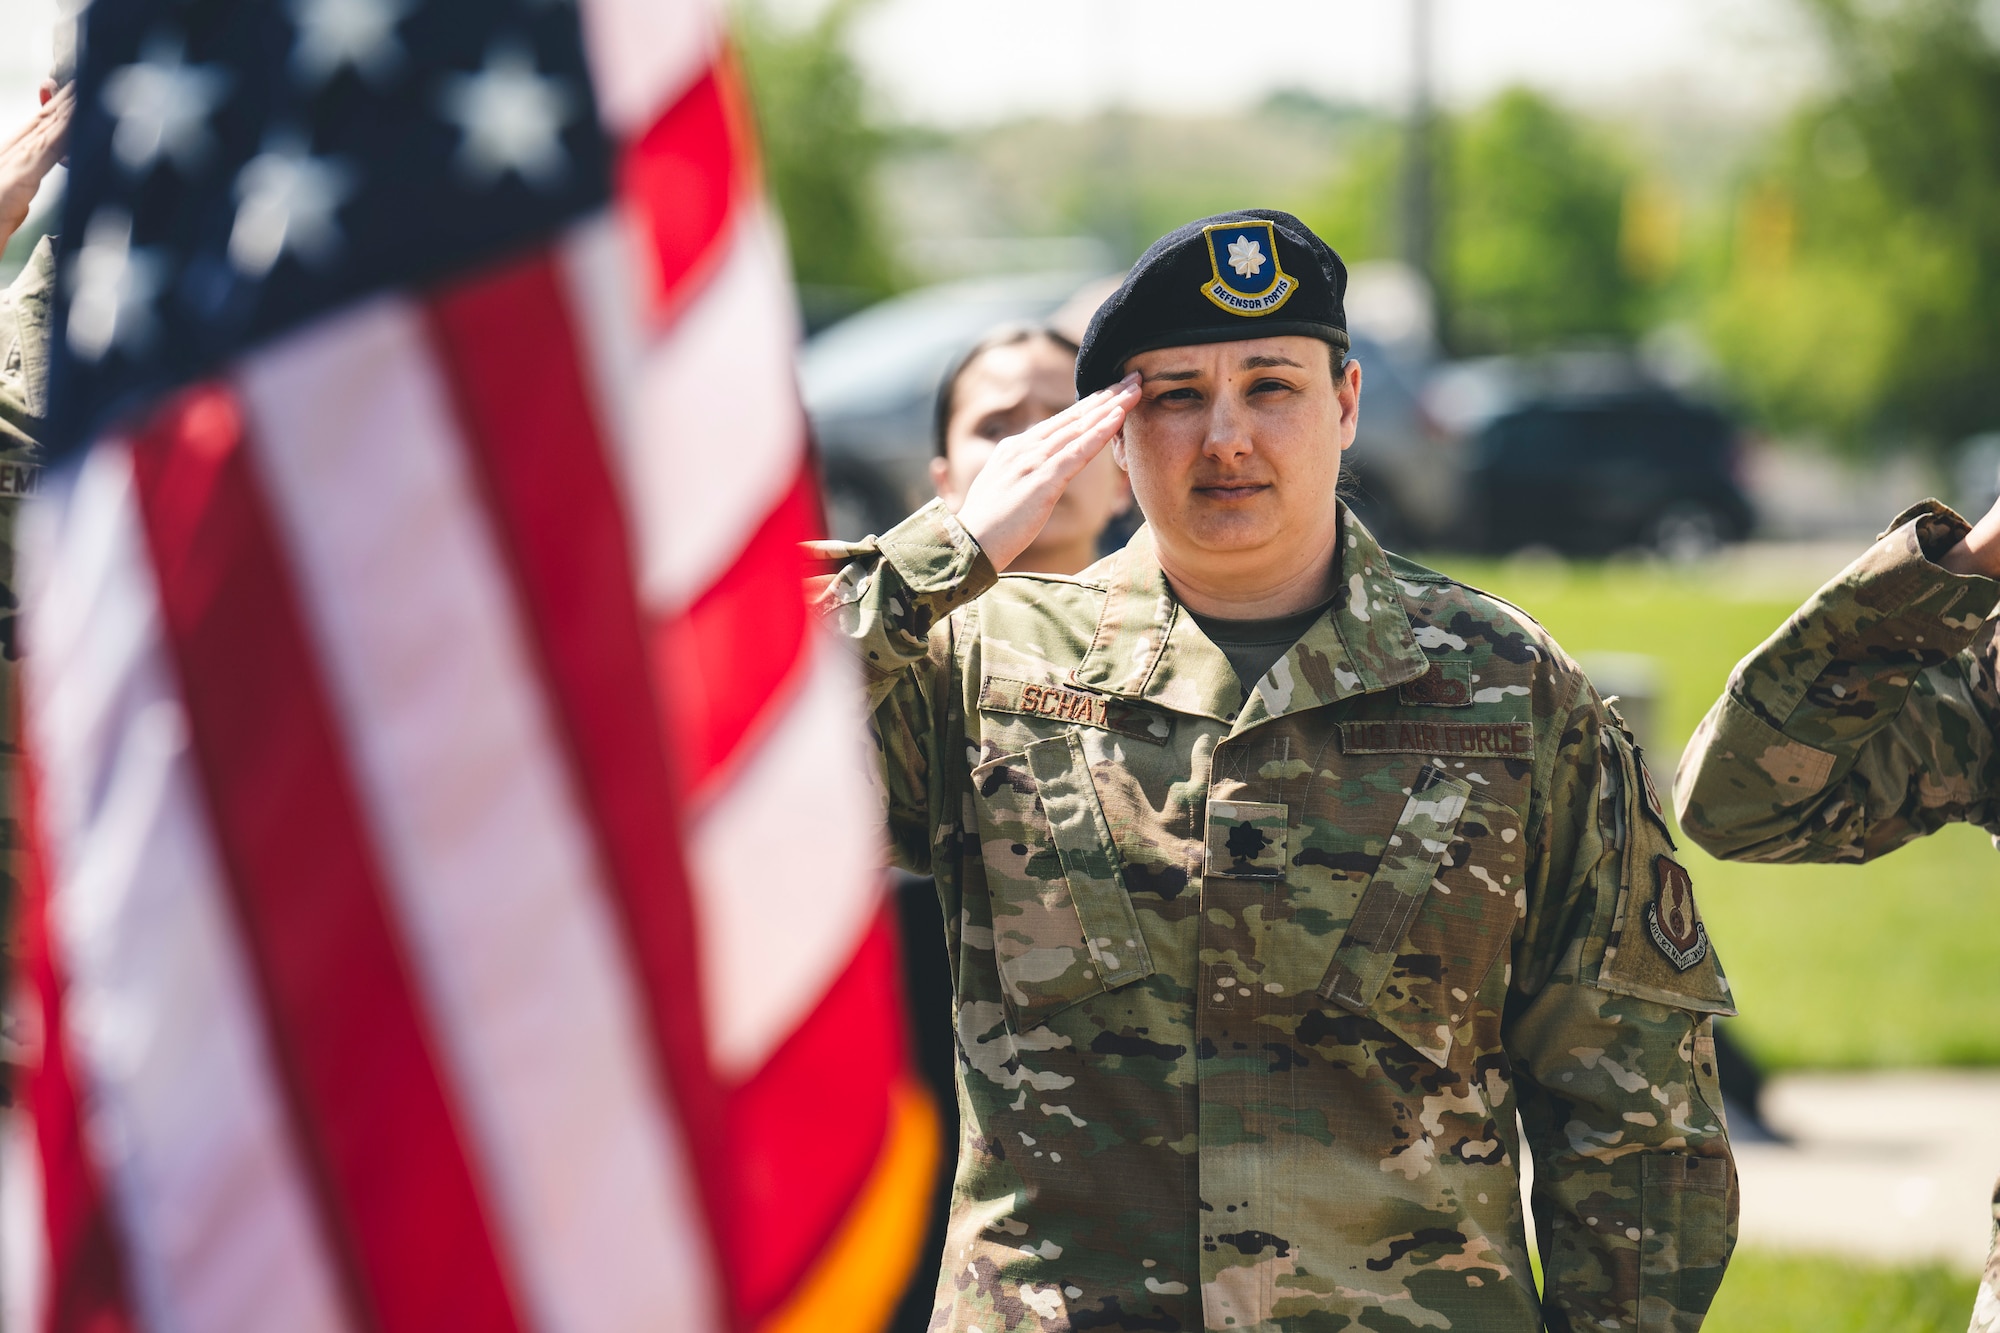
[892,314,1132,1333]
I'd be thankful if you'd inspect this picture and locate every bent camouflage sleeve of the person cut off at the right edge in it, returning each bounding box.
[1678,500,2000,861]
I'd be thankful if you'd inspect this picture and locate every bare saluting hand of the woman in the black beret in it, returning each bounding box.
[958,374,1138,570]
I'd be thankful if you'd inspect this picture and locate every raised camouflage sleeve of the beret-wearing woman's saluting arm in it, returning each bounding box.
[808,500,998,875]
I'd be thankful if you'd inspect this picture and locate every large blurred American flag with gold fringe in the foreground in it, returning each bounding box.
[0,0,934,1333]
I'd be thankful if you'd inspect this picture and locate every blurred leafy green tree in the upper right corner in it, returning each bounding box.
[1704,0,2000,448]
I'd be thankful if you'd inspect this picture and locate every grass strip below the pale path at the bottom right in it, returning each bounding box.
[1702,1251,1978,1333]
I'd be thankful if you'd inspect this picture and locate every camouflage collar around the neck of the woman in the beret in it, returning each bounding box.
[1074,504,1430,735]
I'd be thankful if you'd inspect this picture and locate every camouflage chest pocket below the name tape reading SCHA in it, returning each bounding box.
[972,733,1154,1033]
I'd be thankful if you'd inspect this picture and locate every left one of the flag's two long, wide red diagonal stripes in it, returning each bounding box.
[123,384,520,1333]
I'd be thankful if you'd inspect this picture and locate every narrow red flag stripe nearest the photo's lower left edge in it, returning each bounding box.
[20,748,134,1333]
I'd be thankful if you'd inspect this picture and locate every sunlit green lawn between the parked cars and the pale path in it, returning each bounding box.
[1426,550,2000,1072]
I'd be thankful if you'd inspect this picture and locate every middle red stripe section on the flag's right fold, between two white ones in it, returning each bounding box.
[652,466,820,791]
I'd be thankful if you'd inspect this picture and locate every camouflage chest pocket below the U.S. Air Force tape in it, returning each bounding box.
[1320,767,1524,1067]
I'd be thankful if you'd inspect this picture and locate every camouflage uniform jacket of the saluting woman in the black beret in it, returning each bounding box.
[822,504,1736,1333]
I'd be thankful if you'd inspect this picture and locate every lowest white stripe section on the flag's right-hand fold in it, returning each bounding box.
[688,632,882,1077]
